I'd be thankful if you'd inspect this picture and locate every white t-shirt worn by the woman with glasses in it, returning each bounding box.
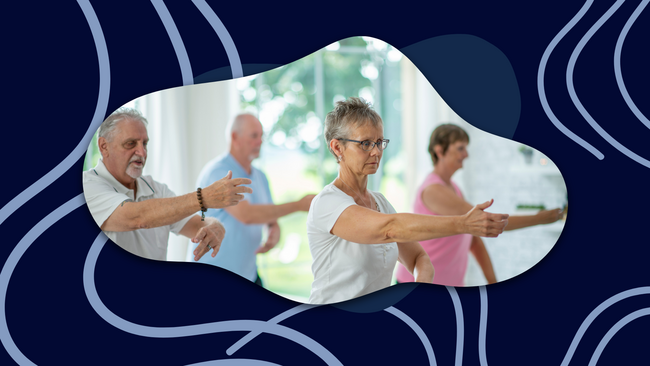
[307,184,398,304]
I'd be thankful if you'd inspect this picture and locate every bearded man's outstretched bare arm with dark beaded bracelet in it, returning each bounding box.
[101,172,253,231]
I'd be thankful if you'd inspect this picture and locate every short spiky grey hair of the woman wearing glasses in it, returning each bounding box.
[324,97,384,157]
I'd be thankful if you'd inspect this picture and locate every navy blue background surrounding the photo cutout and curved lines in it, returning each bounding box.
[0,1,650,365]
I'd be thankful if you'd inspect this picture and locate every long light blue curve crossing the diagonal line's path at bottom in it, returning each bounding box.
[83,232,342,366]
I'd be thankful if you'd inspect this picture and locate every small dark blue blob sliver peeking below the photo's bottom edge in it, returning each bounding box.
[332,282,419,313]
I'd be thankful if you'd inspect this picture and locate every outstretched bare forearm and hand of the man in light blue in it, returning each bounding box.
[226,194,314,224]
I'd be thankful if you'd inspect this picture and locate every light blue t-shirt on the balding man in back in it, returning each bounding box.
[186,153,273,281]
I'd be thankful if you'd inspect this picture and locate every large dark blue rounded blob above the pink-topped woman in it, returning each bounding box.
[400,34,521,139]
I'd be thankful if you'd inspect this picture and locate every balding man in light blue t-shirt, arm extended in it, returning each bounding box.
[187,114,314,285]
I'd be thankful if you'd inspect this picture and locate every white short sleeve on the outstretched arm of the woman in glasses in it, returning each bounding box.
[309,187,355,234]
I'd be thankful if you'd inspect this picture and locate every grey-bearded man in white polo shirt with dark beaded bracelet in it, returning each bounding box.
[83,108,252,260]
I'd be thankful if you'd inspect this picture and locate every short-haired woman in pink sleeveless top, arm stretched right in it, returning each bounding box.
[396,124,562,286]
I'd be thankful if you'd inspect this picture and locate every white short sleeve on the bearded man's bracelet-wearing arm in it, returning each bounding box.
[83,175,129,227]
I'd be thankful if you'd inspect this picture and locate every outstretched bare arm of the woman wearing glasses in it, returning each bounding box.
[331,201,508,244]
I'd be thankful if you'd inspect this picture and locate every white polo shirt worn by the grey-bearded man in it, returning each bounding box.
[83,159,192,260]
